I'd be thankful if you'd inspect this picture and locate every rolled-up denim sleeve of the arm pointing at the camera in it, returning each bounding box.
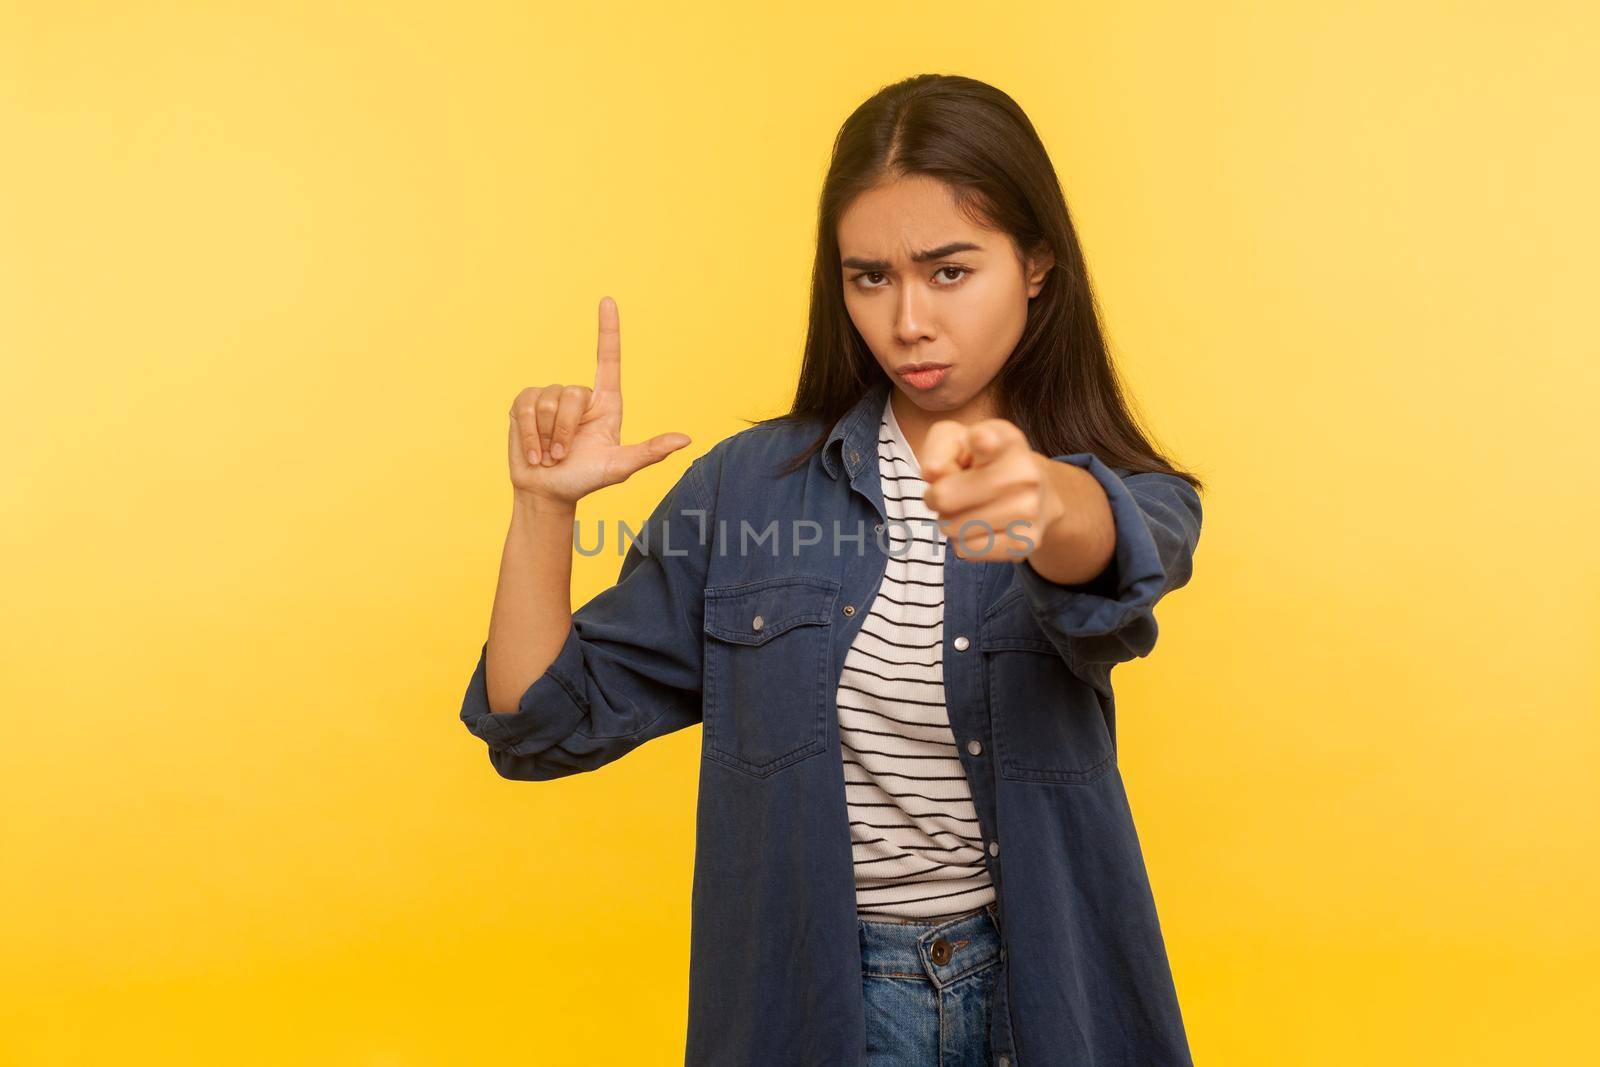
[1013,453,1200,689]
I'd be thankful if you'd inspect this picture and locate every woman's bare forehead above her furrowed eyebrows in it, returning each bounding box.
[838,174,994,259]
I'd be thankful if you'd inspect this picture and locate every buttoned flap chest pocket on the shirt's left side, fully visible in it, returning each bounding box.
[701,576,838,777]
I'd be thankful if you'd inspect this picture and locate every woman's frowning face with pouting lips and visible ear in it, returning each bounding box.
[838,174,1051,422]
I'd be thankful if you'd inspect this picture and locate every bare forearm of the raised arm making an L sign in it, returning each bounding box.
[485,493,576,713]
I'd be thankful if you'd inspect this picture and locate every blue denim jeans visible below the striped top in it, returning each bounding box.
[856,904,1000,1067]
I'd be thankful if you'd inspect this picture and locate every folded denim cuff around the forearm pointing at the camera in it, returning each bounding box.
[1013,453,1166,637]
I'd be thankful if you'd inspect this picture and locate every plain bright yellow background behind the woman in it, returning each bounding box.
[0,3,1600,1067]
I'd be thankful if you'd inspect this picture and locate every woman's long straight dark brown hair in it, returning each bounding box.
[746,74,1203,490]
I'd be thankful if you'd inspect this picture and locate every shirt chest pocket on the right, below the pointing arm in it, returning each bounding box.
[978,592,1115,784]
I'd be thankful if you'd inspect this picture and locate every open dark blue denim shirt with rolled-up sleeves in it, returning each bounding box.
[461,379,1200,1067]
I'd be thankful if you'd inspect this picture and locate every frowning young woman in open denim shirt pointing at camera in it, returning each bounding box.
[461,75,1202,1067]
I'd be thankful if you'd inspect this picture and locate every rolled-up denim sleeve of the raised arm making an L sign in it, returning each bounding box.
[461,458,710,781]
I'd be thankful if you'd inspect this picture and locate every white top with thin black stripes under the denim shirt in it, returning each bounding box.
[838,390,995,921]
